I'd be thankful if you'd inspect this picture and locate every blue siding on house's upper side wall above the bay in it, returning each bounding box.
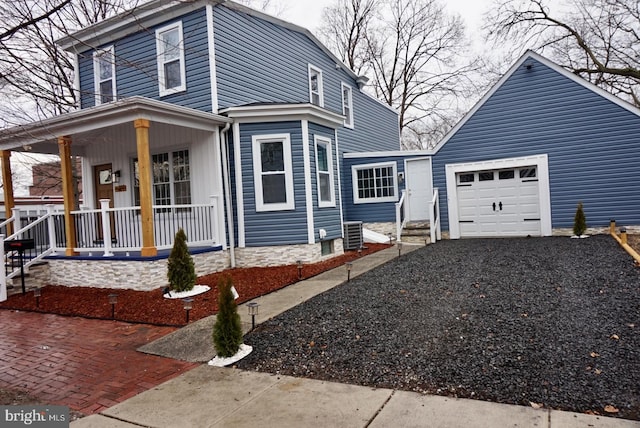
[214,5,400,152]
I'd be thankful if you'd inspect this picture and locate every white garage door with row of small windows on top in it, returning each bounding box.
[456,166,541,237]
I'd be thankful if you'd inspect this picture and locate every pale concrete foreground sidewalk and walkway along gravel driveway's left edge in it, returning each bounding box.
[71,245,640,428]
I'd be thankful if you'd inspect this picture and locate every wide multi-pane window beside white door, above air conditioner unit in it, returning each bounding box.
[351,162,398,204]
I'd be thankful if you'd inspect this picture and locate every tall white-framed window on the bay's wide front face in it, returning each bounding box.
[252,134,295,211]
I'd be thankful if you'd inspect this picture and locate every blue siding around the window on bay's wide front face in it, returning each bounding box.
[240,122,308,247]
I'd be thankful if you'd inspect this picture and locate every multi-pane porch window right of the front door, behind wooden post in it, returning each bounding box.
[133,149,191,210]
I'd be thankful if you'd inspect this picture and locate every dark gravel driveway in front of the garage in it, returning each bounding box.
[238,235,640,420]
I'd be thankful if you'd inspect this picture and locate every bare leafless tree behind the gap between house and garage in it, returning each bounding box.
[321,0,476,149]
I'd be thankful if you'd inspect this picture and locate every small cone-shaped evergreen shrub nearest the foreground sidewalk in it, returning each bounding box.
[213,276,242,358]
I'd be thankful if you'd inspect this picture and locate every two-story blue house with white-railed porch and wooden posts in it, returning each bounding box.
[0,0,402,289]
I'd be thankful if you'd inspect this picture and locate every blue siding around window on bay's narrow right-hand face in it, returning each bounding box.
[309,123,342,242]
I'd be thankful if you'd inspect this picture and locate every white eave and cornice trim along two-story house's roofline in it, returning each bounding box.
[56,0,359,80]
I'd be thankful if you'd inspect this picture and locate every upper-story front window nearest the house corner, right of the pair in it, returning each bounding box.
[156,22,187,96]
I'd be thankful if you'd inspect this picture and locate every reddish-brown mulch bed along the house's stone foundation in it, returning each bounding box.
[0,243,388,326]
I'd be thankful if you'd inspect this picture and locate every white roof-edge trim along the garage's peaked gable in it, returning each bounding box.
[432,50,640,154]
